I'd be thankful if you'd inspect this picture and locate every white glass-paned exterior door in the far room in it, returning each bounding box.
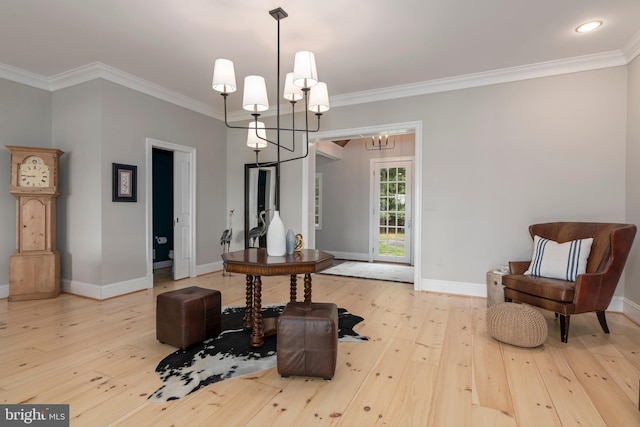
[371,159,413,264]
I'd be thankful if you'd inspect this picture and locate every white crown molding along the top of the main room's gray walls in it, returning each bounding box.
[0,49,640,122]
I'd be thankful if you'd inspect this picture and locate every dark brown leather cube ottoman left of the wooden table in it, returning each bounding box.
[156,286,222,350]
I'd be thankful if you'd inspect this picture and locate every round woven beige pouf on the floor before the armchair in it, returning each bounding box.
[487,302,549,347]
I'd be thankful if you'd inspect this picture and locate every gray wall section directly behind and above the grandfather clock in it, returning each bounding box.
[0,79,51,297]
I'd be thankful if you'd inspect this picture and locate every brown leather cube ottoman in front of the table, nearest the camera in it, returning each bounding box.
[277,302,338,380]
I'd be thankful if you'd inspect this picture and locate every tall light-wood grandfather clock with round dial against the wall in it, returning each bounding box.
[6,145,64,301]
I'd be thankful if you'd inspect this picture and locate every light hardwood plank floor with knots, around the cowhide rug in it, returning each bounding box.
[0,272,640,427]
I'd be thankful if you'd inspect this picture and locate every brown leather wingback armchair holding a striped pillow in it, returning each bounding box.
[502,222,636,343]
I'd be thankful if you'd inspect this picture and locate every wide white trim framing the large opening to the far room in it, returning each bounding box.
[301,120,422,291]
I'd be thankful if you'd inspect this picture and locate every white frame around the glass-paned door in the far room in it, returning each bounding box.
[369,156,415,265]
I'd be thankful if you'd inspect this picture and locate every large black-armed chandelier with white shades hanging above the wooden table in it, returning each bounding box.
[212,7,329,172]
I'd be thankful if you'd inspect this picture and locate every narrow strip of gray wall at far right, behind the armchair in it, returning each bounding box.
[624,57,640,312]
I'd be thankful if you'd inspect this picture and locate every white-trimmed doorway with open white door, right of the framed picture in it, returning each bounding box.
[146,138,196,289]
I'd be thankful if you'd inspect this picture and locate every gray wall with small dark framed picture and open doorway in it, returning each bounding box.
[101,81,227,283]
